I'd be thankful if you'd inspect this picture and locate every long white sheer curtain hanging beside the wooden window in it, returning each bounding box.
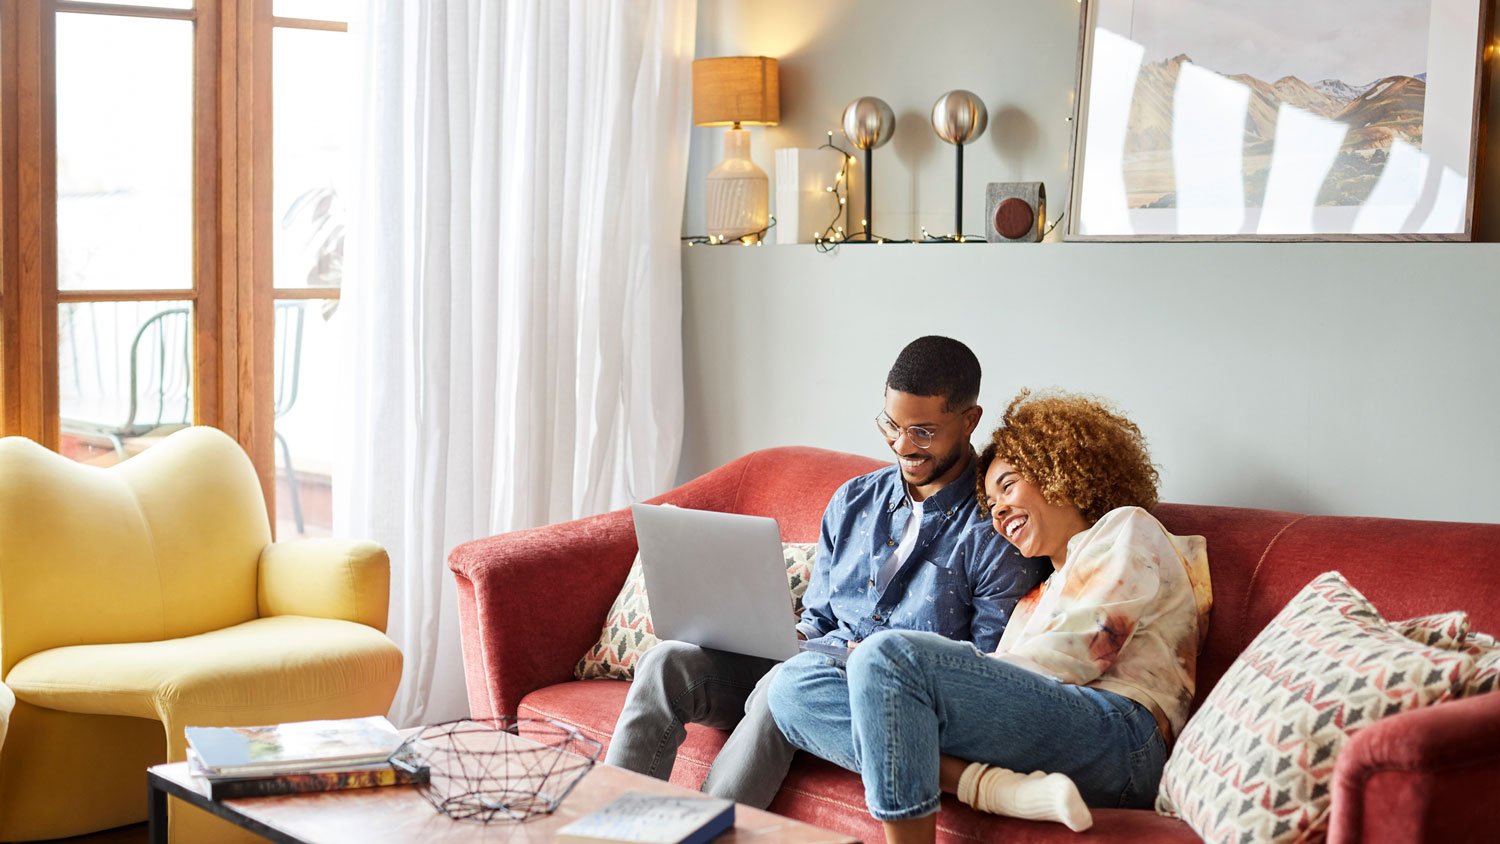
[335,0,696,724]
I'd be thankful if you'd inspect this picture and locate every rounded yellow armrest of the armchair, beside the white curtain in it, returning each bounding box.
[257,540,390,633]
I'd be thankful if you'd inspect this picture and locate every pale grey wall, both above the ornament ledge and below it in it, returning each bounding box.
[680,0,1500,522]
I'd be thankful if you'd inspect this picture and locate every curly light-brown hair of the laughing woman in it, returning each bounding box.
[975,390,1161,525]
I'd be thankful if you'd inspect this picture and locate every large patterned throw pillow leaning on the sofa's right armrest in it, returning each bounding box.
[1157,571,1475,844]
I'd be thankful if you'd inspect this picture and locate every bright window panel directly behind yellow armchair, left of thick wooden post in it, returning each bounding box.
[54,10,195,465]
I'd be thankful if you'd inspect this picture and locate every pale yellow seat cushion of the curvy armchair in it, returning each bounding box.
[5,616,401,723]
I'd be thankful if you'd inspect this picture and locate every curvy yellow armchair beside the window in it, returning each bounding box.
[0,427,401,841]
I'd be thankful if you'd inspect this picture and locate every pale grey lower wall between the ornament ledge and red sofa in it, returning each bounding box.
[681,243,1500,522]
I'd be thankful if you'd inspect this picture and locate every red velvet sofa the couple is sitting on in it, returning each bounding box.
[449,448,1500,843]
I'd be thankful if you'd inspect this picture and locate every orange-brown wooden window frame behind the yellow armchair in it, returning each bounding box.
[0,0,286,513]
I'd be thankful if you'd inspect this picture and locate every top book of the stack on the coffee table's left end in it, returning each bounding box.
[185,715,402,777]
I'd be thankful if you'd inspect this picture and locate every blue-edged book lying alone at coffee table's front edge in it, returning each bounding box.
[557,792,735,844]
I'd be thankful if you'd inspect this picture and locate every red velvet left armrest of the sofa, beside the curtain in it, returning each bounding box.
[449,510,636,718]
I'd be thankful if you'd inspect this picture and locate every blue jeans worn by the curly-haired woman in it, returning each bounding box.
[770,631,1166,820]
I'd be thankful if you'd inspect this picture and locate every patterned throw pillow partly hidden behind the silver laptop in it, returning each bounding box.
[573,543,818,681]
